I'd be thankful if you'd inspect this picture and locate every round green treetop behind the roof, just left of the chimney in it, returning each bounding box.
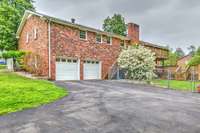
[103,14,126,36]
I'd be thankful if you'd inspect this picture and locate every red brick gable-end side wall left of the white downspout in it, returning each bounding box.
[18,16,48,76]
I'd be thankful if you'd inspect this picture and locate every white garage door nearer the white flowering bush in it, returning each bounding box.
[83,60,101,80]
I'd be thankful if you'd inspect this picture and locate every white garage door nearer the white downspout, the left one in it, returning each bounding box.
[56,58,80,80]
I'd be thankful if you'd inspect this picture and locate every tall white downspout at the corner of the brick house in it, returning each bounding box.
[48,20,51,79]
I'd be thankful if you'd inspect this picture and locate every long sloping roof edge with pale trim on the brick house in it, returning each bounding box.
[16,10,169,50]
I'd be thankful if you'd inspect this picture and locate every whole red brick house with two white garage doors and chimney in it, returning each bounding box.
[17,11,168,80]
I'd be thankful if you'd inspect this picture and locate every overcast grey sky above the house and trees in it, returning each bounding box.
[34,0,200,53]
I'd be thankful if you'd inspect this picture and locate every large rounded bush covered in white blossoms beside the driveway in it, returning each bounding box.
[118,46,155,80]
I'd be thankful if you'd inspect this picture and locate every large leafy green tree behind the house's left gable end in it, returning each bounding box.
[0,0,34,50]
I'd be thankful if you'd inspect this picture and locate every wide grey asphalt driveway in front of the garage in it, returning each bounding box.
[0,81,200,133]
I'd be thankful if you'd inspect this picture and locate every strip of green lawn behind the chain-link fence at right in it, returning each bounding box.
[152,80,200,91]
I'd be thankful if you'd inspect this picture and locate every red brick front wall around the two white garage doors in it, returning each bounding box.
[51,23,120,79]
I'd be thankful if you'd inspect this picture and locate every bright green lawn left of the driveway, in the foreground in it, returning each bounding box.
[0,72,68,114]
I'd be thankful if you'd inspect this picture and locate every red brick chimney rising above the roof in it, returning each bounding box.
[127,23,140,44]
